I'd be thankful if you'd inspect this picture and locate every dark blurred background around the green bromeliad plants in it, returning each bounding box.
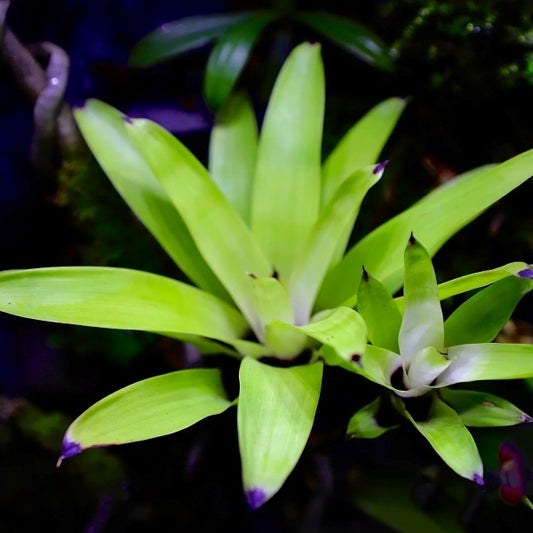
[0,0,533,532]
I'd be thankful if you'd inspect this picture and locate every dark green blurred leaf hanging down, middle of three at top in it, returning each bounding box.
[204,12,276,109]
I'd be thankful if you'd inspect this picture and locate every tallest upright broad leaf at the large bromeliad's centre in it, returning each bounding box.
[251,44,324,279]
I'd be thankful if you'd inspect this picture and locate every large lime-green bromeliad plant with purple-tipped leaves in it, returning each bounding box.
[0,44,533,508]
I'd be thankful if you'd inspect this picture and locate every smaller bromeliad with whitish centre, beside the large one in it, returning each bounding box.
[336,235,533,485]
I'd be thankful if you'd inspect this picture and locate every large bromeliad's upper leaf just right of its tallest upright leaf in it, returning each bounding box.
[322,98,405,205]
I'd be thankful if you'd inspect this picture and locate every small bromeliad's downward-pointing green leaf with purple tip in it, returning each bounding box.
[393,395,484,485]
